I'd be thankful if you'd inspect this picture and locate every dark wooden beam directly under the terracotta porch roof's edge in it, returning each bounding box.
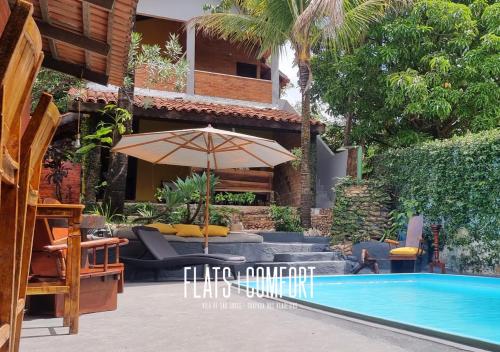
[70,101,325,134]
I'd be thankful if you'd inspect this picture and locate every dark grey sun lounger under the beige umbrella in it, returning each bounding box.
[120,226,246,280]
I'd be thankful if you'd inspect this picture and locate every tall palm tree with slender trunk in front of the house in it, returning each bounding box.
[194,0,396,228]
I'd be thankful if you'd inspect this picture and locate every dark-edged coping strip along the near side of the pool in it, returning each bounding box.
[232,275,500,351]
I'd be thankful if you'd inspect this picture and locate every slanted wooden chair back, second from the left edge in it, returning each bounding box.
[14,94,61,350]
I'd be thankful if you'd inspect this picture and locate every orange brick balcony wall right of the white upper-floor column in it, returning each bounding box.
[194,71,272,103]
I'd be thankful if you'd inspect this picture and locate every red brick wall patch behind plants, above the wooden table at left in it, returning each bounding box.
[40,162,81,203]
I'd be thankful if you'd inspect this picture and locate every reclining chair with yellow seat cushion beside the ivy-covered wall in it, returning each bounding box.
[385,215,424,272]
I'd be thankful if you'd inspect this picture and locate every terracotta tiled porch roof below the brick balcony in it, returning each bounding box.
[70,89,322,125]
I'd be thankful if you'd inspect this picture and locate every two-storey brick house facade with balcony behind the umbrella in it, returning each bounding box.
[60,0,324,206]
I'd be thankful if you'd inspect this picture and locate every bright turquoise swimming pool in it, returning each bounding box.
[240,274,500,351]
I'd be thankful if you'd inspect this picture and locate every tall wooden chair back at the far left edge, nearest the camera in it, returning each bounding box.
[0,1,43,351]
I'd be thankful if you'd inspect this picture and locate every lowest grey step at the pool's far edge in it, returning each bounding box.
[254,260,354,275]
